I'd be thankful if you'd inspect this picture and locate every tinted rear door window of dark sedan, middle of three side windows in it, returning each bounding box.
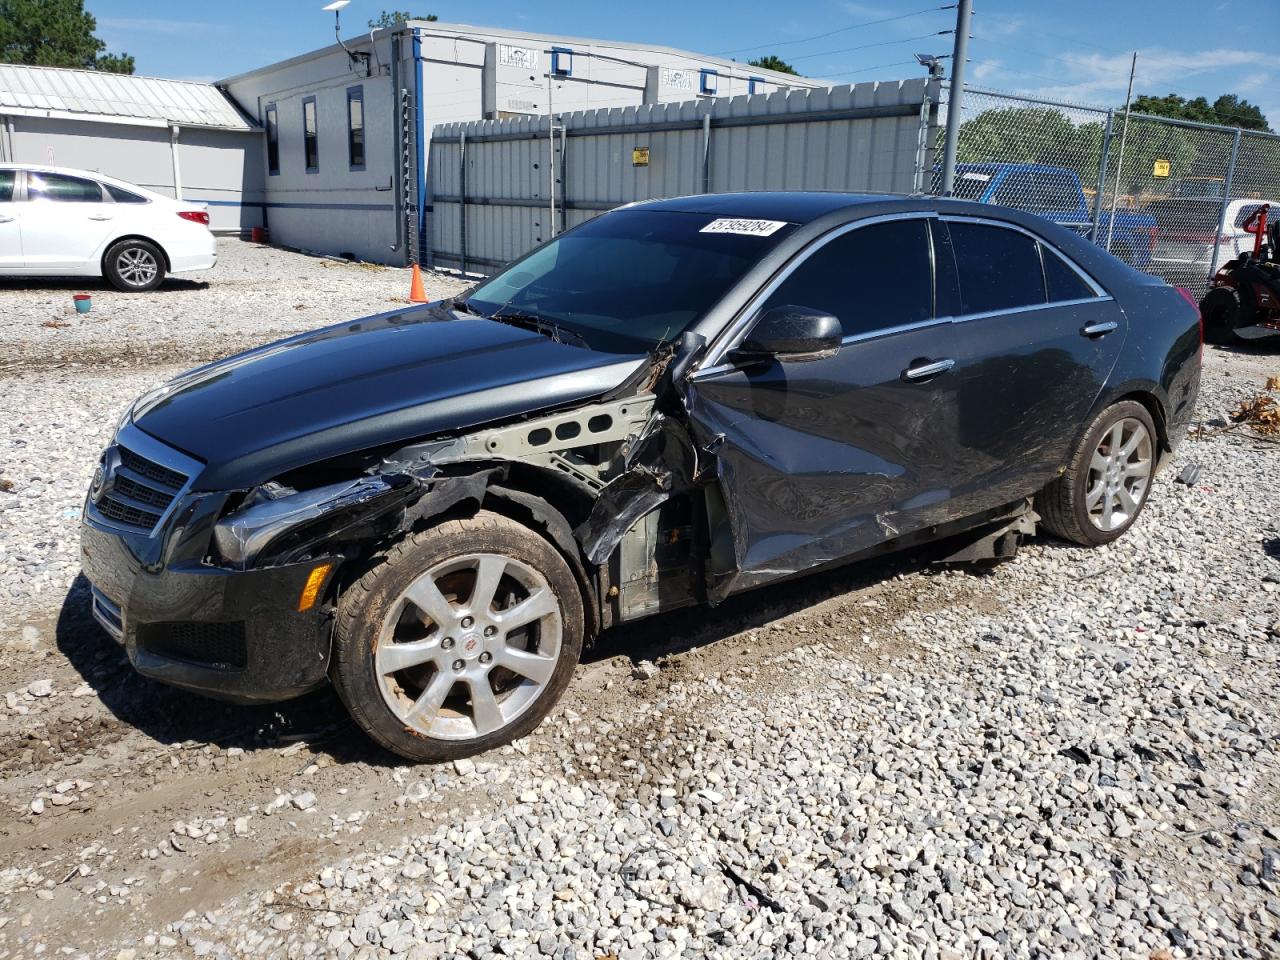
[948,221,1044,314]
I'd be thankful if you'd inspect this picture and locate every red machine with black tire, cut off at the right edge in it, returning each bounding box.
[1201,204,1280,343]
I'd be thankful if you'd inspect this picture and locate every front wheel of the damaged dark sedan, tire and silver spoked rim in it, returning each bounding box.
[332,512,584,760]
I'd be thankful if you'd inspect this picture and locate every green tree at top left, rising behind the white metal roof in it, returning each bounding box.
[0,0,133,73]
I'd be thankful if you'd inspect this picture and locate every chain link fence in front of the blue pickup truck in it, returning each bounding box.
[933,87,1280,296]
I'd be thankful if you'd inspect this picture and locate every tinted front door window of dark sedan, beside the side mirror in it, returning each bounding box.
[764,219,933,337]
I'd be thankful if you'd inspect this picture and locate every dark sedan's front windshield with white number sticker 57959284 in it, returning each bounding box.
[467,210,794,353]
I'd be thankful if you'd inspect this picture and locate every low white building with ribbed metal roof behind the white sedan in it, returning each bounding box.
[0,64,265,232]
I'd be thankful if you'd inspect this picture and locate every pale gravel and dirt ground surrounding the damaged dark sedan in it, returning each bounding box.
[0,246,1280,960]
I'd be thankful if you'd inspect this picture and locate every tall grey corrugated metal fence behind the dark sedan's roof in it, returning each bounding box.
[428,79,938,273]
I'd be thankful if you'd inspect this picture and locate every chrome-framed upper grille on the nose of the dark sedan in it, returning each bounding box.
[88,424,200,535]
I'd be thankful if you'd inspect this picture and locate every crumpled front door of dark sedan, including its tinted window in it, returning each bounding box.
[685,216,964,596]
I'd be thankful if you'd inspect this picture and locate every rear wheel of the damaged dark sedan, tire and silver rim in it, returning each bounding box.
[1036,401,1157,547]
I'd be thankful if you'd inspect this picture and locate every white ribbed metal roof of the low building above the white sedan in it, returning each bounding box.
[0,64,256,131]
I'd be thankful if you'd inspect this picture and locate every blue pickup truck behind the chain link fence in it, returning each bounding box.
[954,164,1160,270]
